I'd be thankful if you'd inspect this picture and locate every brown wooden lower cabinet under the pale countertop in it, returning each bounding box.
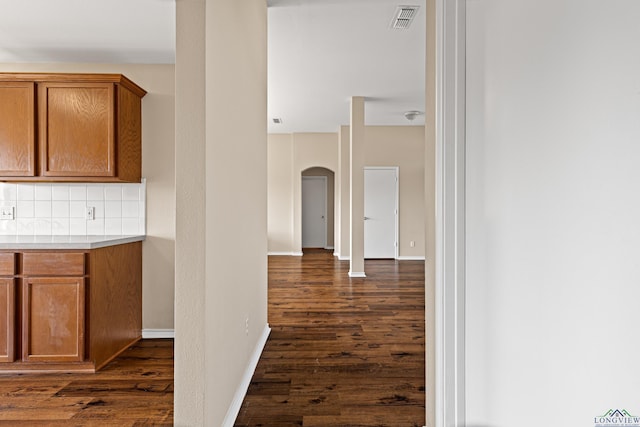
[0,242,142,373]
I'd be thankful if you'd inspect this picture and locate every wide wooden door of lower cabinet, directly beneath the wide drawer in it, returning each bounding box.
[22,277,85,362]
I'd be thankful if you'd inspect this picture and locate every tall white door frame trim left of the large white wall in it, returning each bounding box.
[432,0,466,427]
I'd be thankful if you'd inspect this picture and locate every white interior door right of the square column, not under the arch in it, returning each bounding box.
[364,167,398,258]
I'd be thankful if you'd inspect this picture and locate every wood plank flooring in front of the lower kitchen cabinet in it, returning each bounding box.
[0,340,173,427]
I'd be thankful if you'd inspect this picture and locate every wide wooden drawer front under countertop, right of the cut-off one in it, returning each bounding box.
[22,252,85,276]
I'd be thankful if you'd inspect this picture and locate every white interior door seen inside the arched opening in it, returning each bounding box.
[302,176,327,248]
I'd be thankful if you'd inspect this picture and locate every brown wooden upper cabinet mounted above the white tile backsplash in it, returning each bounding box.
[0,73,146,182]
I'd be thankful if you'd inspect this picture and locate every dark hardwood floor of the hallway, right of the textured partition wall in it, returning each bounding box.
[235,250,425,427]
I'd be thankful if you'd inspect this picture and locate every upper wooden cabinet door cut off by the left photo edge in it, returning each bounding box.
[0,82,36,176]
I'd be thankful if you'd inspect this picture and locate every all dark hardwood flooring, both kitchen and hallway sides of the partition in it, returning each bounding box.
[0,251,425,427]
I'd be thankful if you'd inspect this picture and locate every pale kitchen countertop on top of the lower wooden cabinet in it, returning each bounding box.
[0,235,145,250]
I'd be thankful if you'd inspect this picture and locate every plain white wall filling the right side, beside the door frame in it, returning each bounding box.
[466,0,640,427]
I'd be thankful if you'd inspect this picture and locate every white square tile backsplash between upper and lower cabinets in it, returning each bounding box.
[0,180,146,236]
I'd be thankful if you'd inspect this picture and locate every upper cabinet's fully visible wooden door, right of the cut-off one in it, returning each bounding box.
[38,82,116,177]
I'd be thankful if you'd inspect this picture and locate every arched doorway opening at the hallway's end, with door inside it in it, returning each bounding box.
[301,167,335,251]
